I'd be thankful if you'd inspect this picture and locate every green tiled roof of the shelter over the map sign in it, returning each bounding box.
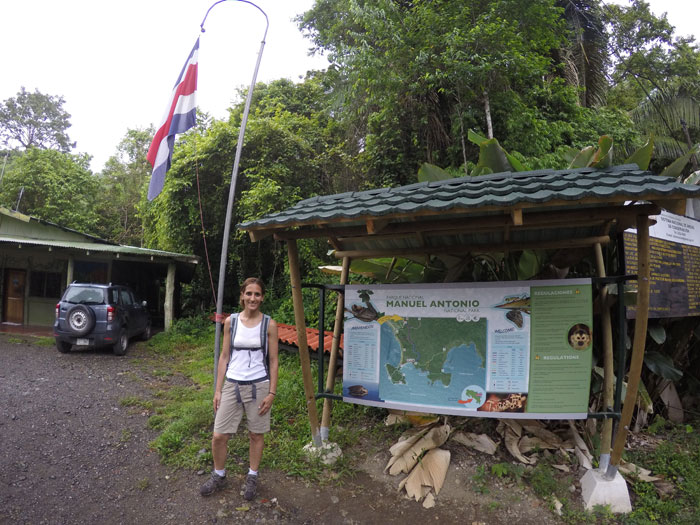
[238,164,700,230]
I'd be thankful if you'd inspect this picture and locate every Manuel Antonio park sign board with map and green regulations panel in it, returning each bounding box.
[343,279,593,419]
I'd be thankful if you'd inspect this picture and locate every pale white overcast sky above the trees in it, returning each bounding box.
[0,0,700,171]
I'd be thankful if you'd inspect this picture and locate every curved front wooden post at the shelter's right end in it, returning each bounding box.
[606,215,650,472]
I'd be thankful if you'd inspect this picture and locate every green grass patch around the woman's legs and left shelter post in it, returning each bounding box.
[144,320,388,480]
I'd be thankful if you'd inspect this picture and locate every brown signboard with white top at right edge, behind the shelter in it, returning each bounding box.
[623,212,700,319]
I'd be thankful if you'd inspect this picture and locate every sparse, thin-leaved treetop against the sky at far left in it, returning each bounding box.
[0,87,75,153]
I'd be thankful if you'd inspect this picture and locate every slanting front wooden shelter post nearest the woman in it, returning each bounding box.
[287,240,322,447]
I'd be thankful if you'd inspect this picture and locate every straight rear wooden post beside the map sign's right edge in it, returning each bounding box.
[594,243,612,472]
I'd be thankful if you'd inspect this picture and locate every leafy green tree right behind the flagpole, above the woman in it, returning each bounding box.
[140,75,344,309]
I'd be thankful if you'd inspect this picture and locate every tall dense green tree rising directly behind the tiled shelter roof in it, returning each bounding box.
[300,0,608,178]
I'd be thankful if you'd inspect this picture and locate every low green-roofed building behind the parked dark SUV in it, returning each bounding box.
[0,207,199,329]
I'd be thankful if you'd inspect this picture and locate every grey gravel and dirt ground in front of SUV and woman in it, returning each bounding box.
[0,334,576,525]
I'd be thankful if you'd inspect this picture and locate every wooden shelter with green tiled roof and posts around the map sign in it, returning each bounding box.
[239,165,700,466]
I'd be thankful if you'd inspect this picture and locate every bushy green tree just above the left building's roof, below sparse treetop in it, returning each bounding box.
[0,148,101,230]
